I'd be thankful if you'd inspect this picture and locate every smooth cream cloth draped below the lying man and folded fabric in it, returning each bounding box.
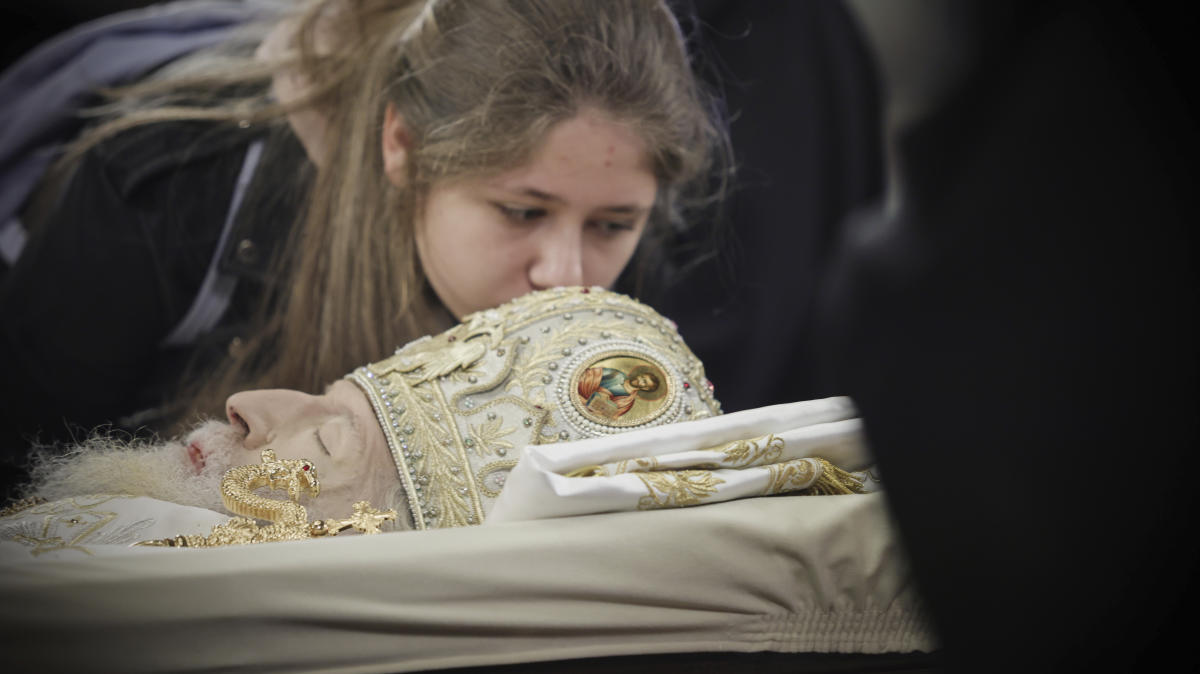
[0,494,935,673]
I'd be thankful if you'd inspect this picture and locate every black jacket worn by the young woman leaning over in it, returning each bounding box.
[0,122,308,486]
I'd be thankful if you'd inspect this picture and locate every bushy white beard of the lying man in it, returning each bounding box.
[26,421,242,512]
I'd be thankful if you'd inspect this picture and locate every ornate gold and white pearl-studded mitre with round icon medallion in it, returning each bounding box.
[347,288,721,529]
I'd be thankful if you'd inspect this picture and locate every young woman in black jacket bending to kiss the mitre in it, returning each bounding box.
[0,0,727,472]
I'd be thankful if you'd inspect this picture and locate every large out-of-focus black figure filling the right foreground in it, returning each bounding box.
[820,0,1198,672]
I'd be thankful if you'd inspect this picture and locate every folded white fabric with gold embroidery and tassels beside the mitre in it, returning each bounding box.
[485,397,878,524]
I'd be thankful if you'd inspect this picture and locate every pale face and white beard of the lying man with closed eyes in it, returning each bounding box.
[34,380,403,518]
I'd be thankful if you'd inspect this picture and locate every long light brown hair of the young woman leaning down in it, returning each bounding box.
[68,0,730,422]
